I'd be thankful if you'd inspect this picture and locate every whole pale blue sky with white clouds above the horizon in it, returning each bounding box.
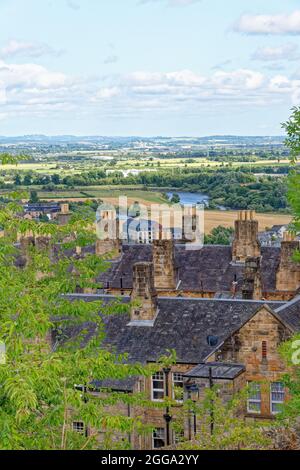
[0,0,300,136]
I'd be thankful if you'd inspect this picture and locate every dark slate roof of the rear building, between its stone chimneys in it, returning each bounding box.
[98,245,280,292]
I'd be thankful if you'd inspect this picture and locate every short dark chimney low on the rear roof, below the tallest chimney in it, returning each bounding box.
[242,257,263,300]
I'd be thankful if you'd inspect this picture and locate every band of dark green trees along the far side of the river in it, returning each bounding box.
[1,166,287,212]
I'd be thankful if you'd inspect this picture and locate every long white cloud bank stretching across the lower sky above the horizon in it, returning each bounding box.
[0,56,300,119]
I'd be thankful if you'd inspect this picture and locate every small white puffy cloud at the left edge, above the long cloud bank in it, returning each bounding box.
[0,39,62,58]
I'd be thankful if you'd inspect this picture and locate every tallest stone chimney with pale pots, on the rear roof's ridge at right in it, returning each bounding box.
[232,211,260,263]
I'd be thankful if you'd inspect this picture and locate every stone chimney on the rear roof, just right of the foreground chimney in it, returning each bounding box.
[152,233,177,290]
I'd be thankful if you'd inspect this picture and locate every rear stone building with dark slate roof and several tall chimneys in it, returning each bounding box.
[97,211,300,301]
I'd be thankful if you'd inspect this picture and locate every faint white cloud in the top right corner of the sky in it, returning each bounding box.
[234,10,300,34]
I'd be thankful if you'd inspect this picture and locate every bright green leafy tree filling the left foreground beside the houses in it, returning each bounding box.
[0,155,157,450]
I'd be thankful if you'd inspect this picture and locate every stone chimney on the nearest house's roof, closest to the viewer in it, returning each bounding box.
[130,262,157,326]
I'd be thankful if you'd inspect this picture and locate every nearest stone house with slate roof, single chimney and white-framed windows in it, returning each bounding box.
[63,262,300,449]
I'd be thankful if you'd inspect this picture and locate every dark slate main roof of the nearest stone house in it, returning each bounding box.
[63,295,282,365]
